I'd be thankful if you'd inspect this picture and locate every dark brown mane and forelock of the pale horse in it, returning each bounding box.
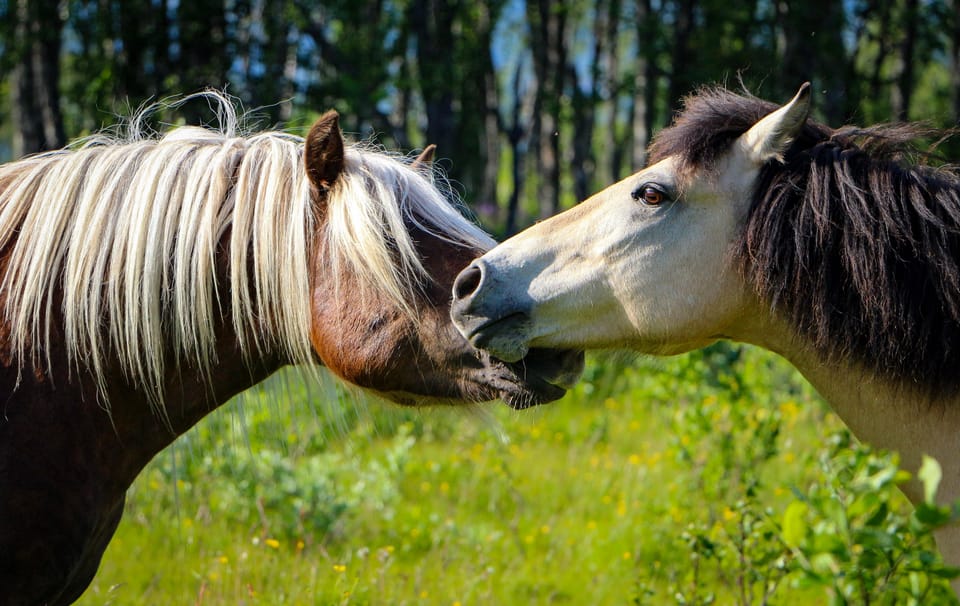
[651,89,960,396]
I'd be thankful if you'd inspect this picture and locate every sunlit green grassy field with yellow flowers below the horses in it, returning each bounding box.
[73,345,947,606]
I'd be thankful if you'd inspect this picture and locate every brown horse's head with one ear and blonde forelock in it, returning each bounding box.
[304,112,583,408]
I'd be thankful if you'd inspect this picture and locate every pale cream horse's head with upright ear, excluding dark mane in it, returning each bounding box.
[452,84,810,361]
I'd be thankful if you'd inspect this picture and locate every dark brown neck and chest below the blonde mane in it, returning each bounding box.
[0,291,282,604]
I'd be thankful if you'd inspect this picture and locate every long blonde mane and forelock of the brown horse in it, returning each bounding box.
[0,93,493,414]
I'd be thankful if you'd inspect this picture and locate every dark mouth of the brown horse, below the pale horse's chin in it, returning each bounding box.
[491,348,584,410]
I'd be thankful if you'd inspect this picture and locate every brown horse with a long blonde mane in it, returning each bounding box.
[0,96,582,605]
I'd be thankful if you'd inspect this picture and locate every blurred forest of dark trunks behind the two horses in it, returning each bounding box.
[0,0,960,235]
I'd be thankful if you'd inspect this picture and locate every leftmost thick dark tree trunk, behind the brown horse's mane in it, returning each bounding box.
[10,0,66,157]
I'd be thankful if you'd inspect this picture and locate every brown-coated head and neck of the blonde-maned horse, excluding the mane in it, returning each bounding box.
[0,113,582,606]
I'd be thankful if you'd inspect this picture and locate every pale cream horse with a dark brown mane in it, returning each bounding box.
[452,84,960,590]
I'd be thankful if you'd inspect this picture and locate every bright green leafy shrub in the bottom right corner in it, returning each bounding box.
[781,431,960,604]
